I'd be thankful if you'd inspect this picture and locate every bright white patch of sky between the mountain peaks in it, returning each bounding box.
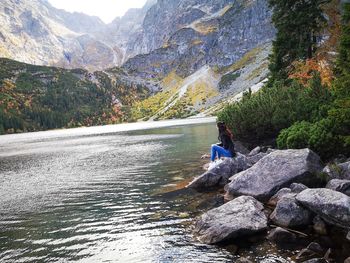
[49,0,146,23]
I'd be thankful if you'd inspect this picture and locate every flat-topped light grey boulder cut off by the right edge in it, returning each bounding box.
[296,188,350,229]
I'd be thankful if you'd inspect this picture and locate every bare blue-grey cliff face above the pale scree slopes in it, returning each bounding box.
[123,0,275,78]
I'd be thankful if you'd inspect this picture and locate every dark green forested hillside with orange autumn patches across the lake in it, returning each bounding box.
[0,59,149,133]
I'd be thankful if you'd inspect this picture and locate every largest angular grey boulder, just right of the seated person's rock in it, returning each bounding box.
[225,149,322,201]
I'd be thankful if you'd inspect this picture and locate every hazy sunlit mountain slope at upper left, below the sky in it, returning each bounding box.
[0,0,156,71]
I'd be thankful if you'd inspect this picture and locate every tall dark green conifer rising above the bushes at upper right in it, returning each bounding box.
[269,0,329,81]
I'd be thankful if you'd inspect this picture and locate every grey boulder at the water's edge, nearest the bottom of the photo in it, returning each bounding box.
[194,196,267,244]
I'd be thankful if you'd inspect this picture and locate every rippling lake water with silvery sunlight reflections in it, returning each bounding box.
[0,119,296,262]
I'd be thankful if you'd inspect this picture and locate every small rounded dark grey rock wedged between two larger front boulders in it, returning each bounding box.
[270,196,312,227]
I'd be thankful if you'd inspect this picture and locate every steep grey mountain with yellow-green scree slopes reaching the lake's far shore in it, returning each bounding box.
[122,0,275,119]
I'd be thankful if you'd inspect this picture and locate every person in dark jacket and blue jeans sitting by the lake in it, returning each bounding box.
[210,121,236,162]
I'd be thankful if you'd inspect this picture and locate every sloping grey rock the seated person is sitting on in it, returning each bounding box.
[187,153,251,191]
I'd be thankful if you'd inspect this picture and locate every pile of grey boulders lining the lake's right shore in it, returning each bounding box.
[187,147,350,263]
